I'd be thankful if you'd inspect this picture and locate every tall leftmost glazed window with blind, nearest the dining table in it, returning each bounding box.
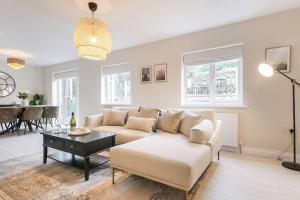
[52,71,79,120]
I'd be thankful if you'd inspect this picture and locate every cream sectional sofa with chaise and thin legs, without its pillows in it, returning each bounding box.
[86,108,222,199]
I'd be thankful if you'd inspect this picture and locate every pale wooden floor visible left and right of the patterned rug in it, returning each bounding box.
[0,134,300,200]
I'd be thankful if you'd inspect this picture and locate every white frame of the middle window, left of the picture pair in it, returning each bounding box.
[100,62,132,106]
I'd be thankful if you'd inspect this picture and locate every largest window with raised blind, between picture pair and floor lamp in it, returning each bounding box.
[182,45,243,107]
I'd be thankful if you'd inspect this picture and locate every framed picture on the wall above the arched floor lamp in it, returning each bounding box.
[266,46,291,72]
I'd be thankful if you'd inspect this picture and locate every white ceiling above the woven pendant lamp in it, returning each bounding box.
[0,0,300,66]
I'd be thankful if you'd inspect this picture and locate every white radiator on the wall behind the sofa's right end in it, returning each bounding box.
[216,113,239,147]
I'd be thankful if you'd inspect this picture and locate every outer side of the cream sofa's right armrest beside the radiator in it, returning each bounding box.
[207,120,222,160]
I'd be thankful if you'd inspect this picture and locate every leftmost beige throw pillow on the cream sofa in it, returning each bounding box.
[103,109,127,126]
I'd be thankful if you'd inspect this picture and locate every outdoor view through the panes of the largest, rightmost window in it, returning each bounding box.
[185,59,241,104]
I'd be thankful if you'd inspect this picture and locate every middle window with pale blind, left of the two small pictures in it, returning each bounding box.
[101,63,131,105]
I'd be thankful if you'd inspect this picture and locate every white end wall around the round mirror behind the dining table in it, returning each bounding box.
[0,61,43,104]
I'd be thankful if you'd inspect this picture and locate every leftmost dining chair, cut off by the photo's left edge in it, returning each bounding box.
[0,107,18,135]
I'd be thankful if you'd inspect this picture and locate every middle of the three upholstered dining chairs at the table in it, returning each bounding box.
[17,107,44,135]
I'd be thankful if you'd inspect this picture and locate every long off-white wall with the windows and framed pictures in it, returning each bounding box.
[44,9,300,155]
